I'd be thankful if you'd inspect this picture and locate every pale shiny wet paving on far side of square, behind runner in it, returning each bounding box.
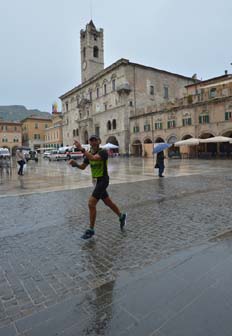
[0,158,232,197]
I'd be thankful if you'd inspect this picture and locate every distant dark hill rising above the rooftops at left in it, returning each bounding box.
[0,105,51,121]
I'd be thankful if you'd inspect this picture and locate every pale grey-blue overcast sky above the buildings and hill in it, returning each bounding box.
[0,0,232,112]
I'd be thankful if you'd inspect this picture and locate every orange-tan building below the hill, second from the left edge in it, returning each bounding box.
[21,116,52,149]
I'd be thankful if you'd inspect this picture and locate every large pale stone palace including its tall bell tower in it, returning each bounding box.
[60,21,197,154]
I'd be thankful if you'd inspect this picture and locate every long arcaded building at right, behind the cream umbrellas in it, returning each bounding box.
[130,72,232,156]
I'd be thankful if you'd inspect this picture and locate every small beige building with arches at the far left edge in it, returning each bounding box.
[0,120,22,153]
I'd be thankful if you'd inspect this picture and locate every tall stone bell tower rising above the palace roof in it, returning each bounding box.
[80,20,104,83]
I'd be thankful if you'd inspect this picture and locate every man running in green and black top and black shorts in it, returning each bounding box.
[69,135,127,239]
